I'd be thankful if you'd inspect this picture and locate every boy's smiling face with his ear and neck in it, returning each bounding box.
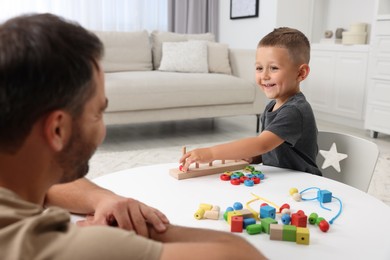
[256,46,309,109]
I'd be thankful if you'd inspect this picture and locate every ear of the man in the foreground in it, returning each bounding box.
[43,110,72,152]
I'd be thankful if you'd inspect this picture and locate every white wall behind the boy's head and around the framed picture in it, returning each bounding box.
[219,0,375,49]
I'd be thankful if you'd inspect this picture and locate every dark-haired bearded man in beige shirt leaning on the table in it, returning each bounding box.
[0,14,263,259]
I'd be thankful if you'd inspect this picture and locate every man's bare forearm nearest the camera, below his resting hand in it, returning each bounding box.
[150,225,266,260]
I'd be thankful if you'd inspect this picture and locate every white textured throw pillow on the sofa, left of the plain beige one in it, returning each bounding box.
[159,41,209,73]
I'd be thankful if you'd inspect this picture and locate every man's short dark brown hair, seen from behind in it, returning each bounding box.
[0,14,104,152]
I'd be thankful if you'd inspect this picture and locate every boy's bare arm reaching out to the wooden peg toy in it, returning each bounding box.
[180,130,284,171]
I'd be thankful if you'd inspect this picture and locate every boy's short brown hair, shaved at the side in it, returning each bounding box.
[257,27,310,64]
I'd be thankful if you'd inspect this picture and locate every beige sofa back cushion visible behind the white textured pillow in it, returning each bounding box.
[150,31,215,70]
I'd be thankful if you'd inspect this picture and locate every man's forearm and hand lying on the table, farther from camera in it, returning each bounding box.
[45,178,169,237]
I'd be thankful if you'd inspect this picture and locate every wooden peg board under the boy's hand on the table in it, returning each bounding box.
[169,146,249,180]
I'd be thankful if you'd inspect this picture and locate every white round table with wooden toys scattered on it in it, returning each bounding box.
[93,163,390,259]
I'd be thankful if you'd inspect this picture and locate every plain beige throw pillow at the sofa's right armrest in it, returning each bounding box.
[207,42,232,75]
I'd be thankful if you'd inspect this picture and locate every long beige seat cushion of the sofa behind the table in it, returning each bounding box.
[106,71,256,112]
